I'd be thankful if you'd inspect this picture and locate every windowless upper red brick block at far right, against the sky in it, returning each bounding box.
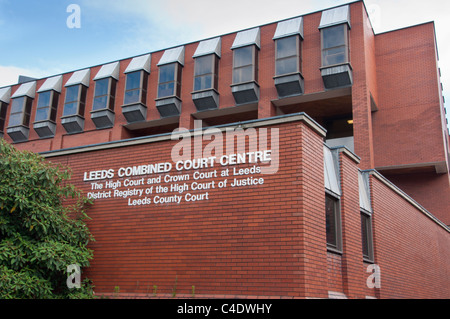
[373,23,445,167]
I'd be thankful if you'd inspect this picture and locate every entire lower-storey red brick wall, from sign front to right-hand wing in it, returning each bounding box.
[39,116,450,298]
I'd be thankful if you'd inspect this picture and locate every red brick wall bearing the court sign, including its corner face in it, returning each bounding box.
[45,119,326,297]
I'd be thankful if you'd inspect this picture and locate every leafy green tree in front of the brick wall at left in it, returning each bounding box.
[0,139,94,299]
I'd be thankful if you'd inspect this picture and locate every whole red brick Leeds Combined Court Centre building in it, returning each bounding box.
[0,1,450,298]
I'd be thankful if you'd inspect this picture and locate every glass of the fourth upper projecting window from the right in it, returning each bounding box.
[194,54,218,91]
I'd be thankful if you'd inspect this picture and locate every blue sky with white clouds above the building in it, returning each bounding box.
[0,0,450,127]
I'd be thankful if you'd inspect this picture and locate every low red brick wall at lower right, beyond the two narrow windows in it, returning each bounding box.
[371,177,450,299]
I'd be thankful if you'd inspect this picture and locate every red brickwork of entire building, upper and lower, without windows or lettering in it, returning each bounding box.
[0,1,450,298]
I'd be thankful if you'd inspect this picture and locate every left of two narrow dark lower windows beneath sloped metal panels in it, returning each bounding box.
[325,194,341,249]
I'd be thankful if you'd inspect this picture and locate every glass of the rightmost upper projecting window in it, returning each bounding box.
[321,24,349,66]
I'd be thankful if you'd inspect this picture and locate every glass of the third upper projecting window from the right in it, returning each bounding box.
[233,46,257,83]
